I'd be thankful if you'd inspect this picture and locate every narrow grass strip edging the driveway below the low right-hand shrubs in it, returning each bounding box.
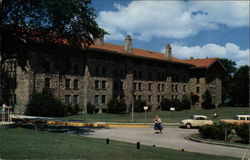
[191,134,249,147]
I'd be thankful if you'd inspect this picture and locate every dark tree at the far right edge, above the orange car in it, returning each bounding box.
[231,65,249,107]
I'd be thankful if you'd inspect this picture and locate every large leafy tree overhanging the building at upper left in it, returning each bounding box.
[0,0,106,105]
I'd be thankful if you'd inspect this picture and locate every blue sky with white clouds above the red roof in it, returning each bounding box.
[92,0,250,66]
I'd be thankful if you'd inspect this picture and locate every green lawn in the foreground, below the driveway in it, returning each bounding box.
[0,128,237,160]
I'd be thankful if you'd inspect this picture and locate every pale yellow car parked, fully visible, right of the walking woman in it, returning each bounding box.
[180,115,213,128]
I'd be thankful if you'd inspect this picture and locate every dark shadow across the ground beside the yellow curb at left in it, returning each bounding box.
[16,122,108,135]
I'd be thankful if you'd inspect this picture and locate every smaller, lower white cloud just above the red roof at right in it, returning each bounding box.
[168,43,250,66]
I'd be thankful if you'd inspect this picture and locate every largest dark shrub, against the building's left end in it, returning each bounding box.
[25,89,65,117]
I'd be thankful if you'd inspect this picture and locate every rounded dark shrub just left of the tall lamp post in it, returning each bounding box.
[108,98,127,114]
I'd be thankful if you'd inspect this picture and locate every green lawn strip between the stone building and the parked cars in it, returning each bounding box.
[62,107,249,122]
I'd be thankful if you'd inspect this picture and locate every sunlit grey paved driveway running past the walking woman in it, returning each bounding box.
[87,126,249,158]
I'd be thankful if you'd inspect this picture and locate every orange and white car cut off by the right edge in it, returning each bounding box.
[220,115,250,124]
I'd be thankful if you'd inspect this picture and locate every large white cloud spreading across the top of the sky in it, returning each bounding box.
[97,1,249,41]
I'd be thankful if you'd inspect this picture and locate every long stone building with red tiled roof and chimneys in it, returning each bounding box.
[0,36,225,113]
